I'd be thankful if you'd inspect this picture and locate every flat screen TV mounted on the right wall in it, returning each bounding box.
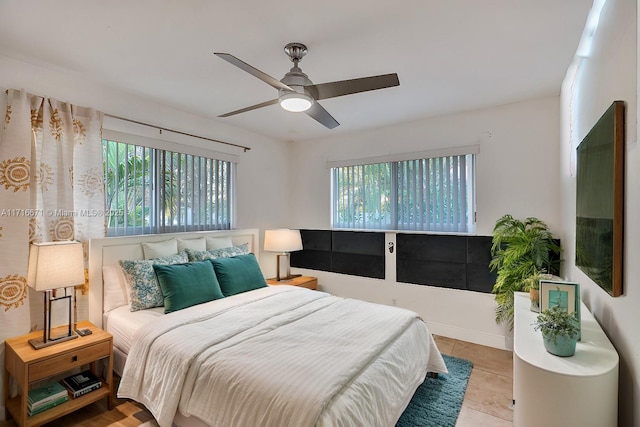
[576,101,625,296]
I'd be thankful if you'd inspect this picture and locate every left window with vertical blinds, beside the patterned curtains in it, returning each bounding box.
[102,139,234,236]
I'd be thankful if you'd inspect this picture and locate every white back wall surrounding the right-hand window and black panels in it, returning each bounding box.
[289,96,561,348]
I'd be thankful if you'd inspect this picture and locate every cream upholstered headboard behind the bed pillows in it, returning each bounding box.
[89,228,260,327]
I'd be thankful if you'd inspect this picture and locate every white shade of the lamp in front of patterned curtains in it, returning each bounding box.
[27,242,84,291]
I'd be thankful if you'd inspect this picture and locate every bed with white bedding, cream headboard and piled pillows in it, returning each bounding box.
[89,229,447,427]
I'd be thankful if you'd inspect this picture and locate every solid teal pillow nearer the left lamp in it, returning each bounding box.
[153,261,224,313]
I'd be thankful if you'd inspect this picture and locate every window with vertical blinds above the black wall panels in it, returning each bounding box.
[331,154,475,233]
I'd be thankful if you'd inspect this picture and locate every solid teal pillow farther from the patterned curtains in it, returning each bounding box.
[209,254,267,297]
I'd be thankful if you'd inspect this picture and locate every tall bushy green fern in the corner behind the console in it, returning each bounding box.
[489,214,560,329]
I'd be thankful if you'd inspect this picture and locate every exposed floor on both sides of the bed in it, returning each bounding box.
[0,336,513,427]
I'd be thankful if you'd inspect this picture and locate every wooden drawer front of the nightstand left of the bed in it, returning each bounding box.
[28,341,111,382]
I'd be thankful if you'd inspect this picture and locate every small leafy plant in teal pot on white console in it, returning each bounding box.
[533,305,579,357]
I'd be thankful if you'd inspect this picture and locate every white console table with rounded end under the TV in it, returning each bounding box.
[513,292,618,427]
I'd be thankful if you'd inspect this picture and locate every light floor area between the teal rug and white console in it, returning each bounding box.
[435,336,513,427]
